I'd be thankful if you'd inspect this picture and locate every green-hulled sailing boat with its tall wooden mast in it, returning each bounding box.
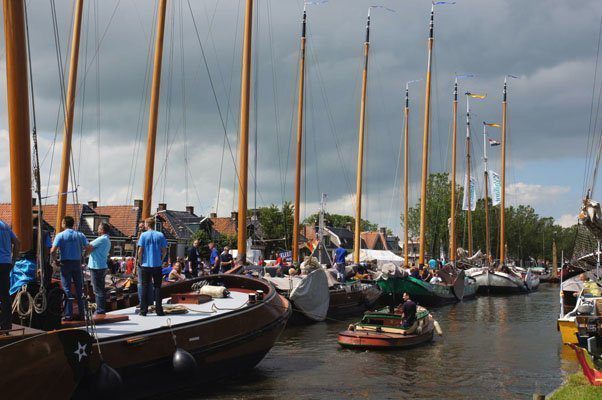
[377,3,468,306]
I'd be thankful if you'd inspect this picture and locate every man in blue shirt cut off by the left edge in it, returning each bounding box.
[0,220,20,330]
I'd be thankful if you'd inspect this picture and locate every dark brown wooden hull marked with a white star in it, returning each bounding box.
[0,329,92,399]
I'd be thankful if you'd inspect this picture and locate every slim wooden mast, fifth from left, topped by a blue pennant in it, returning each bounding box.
[293,9,307,262]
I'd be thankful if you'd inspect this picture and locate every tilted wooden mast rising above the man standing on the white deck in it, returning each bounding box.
[142,0,167,219]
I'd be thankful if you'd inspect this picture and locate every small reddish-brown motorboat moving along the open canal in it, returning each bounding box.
[338,306,442,350]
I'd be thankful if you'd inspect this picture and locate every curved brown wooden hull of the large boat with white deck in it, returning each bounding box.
[75,275,291,399]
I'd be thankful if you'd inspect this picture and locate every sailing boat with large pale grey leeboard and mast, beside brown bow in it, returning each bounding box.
[264,2,381,325]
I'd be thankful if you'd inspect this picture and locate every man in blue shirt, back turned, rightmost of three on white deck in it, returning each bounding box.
[138,218,167,317]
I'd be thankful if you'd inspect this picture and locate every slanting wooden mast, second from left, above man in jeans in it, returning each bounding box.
[55,0,84,232]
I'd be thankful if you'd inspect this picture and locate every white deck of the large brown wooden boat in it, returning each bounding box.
[96,291,249,339]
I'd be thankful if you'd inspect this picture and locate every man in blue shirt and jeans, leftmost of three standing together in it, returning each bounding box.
[50,216,88,321]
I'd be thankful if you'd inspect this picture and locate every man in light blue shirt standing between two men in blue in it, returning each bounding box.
[88,222,111,314]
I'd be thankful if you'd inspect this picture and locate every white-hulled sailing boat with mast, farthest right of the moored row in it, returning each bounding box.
[466,75,539,294]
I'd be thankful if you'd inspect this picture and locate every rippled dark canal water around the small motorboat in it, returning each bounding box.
[175,284,578,400]
